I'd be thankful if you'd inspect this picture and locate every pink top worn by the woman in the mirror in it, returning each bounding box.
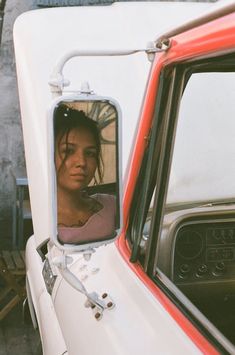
[58,194,116,244]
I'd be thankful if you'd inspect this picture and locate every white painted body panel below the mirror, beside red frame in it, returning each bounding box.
[53,244,201,355]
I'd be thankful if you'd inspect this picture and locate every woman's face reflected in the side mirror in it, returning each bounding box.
[55,127,98,192]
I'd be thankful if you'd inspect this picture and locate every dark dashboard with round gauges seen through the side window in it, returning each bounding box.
[158,204,235,343]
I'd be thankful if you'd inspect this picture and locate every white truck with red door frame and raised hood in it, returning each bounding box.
[14,1,235,355]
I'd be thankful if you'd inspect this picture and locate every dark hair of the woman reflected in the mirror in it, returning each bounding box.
[54,103,103,184]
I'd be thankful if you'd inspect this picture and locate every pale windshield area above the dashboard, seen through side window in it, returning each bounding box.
[167,73,235,203]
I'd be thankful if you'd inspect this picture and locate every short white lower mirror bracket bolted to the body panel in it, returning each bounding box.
[52,253,115,320]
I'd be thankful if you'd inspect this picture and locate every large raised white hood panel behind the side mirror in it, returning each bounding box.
[14,2,211,245]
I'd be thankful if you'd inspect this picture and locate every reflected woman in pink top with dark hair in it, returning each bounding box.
[55,104,115,243]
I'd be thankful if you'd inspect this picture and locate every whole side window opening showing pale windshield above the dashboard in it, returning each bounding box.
[154,72,235,343]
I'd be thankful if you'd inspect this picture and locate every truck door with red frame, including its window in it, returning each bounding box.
[120,8,235,353]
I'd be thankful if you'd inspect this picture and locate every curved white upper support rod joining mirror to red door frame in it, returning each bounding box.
[49,42,165,96]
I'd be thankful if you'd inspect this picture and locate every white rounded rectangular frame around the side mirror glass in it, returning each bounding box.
[47,94,123,252]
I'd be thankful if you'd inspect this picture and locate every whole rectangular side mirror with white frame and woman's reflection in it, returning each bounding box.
[49,94,122,251]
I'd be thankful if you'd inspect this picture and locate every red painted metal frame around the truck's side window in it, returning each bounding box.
[117,13,235,354]
